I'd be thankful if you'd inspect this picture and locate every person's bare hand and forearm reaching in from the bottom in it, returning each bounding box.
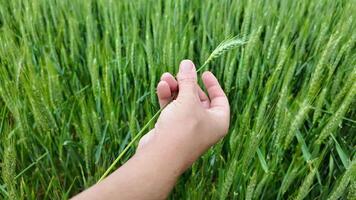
[73,60,230,200]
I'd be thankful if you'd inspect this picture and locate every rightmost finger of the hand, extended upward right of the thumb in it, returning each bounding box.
[202,72,229,111]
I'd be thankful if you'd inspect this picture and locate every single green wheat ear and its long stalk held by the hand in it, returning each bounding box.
[98,36,247,183]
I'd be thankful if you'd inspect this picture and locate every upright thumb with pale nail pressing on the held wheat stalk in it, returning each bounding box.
[177,60,197,97]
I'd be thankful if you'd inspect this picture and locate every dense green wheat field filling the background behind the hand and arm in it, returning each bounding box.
[0,0,356,199]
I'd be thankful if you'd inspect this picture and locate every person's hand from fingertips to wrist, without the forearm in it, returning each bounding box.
[137,60,230,170]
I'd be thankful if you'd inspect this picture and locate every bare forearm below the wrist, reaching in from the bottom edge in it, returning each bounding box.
[74,132,186,199]
